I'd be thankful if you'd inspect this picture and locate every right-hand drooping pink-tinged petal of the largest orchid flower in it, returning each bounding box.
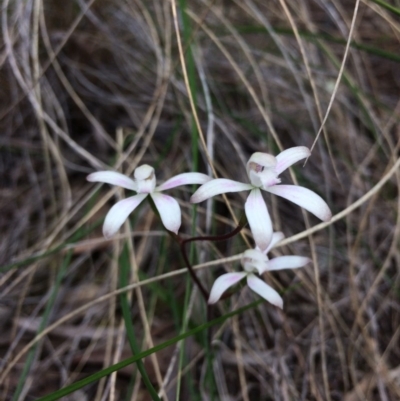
[266,185,332,221]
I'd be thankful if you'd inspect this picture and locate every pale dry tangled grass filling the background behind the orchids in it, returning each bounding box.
[0,0,400,401]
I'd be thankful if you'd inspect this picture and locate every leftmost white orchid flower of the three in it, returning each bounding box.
[87,164,211,238]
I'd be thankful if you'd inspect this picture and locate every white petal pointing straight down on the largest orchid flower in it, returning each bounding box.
[244,188,272,251]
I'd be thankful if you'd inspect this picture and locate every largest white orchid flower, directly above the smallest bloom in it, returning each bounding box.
[190,146,332,250]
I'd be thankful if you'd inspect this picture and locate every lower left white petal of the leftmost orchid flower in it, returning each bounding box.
[103,194,147,238]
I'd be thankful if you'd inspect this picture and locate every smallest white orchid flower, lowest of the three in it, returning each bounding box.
[208,232,310,309]
